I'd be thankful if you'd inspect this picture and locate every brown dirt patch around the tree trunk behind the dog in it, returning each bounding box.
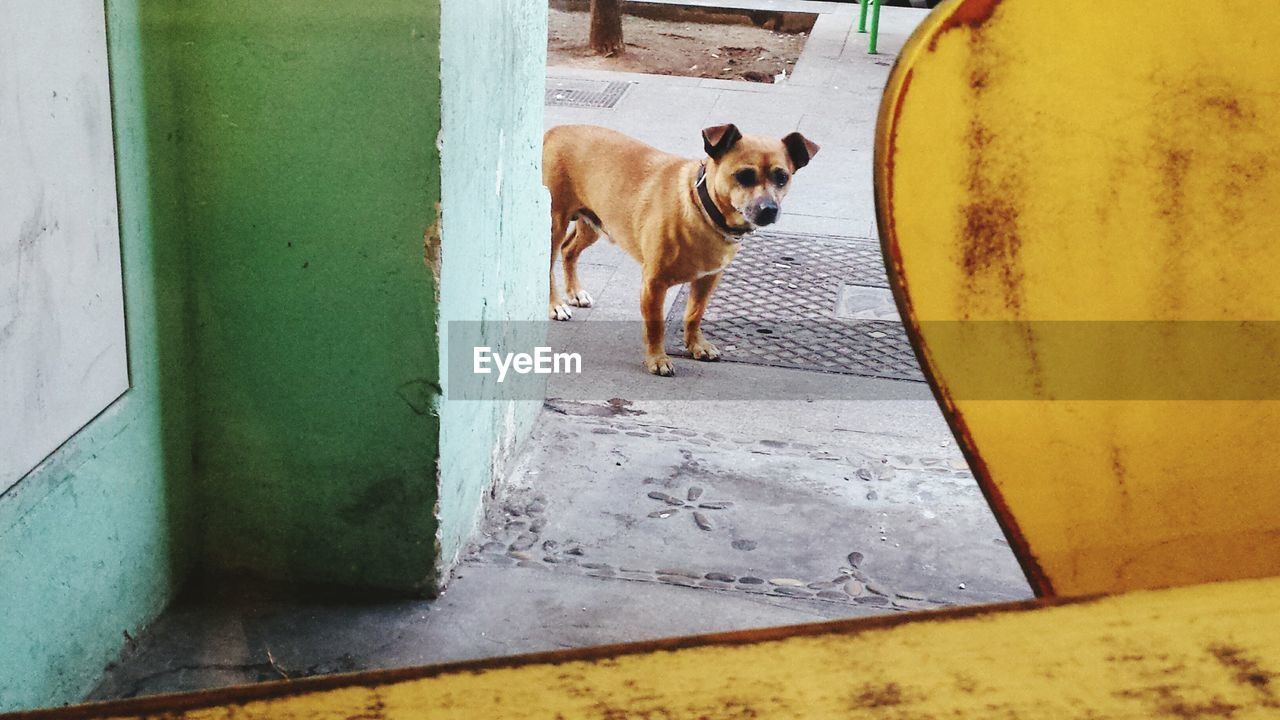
[547,8,809,82]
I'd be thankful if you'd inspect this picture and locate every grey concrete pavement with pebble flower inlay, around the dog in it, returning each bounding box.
[93,0,1030,698]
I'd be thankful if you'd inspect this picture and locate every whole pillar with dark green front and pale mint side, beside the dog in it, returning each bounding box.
[145,0,549,594]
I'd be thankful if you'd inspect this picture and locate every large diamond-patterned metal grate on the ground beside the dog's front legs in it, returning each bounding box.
[667,232,924,382]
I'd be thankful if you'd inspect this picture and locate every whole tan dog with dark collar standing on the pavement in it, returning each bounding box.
[543,124,818,375]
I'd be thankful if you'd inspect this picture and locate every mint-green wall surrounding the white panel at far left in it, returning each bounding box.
[0,0,195,711]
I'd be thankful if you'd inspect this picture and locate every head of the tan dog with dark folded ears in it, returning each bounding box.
[703,124,818,228]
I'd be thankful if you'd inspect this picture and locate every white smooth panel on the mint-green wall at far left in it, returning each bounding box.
[0,0,128,492]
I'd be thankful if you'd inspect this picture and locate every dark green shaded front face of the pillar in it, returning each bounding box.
[146,0,440,592]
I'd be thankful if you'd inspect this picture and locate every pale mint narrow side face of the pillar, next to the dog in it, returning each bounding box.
[440,0,550,566]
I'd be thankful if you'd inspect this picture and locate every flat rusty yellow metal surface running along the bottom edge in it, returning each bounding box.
[10,579,1280,720]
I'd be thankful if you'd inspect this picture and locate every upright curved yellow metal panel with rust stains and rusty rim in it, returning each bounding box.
[876,0,1280,596]
